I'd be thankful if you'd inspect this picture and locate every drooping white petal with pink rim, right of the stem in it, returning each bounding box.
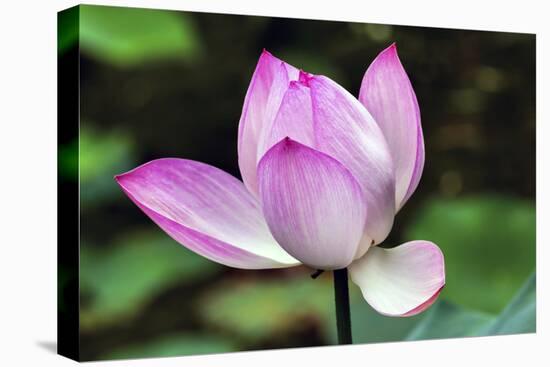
[349,241,445,317]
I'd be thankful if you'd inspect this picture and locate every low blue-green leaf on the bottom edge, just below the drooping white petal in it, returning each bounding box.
[405,300,494,340]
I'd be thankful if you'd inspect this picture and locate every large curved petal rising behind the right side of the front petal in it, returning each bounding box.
[308,76,395,243]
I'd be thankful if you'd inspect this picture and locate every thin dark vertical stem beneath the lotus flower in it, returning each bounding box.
[333,268,352,344]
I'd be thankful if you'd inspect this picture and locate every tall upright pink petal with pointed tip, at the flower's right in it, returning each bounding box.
[359,44,424,210]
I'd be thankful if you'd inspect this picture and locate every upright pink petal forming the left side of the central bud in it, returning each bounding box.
[238,50,298,195]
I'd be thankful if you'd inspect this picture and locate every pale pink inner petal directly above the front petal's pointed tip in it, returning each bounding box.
[258,81,313,158]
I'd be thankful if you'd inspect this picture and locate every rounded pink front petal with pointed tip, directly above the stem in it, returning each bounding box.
[258,138,366,269]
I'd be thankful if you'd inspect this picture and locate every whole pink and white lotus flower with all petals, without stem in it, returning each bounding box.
[116,45,445,316]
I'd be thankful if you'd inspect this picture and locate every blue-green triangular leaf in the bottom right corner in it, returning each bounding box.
[479,273,536,335]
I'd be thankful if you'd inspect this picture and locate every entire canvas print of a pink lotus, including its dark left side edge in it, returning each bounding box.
[58,5,536,361]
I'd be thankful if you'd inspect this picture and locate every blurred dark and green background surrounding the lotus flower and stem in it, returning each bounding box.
[59,6,535,360]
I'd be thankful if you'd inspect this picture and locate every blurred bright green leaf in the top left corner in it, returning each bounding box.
[80,5,200,67]
